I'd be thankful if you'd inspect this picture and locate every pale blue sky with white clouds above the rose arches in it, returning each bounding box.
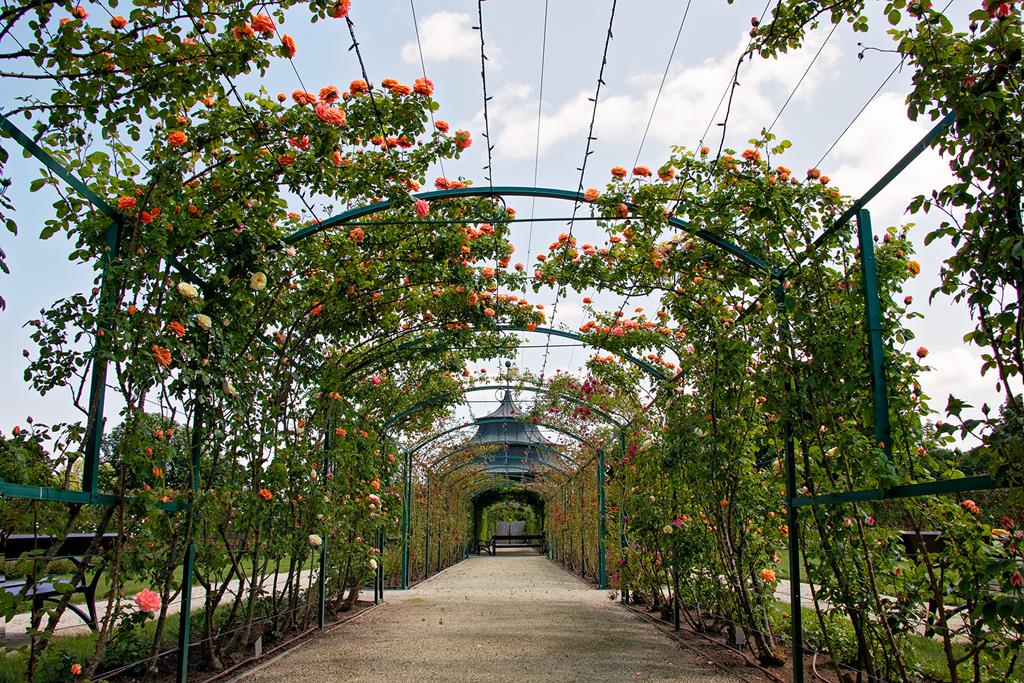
[0,0,998,446]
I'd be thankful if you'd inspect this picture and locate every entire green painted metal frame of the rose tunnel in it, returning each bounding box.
[0,102,1001,683]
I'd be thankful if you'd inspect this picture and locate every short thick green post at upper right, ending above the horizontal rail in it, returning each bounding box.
[857,209,893,460]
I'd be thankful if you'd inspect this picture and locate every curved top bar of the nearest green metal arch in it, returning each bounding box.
[283,185,776,275]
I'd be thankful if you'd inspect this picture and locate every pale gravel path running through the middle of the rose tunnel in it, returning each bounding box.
[244,551,738,683]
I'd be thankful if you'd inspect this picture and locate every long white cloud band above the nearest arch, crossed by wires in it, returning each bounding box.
[494,26,842,159]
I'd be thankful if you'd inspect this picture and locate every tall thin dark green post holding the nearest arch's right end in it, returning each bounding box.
[775,283,804,683]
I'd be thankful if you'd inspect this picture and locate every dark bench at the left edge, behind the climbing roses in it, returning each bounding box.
[0,533,118,631]
